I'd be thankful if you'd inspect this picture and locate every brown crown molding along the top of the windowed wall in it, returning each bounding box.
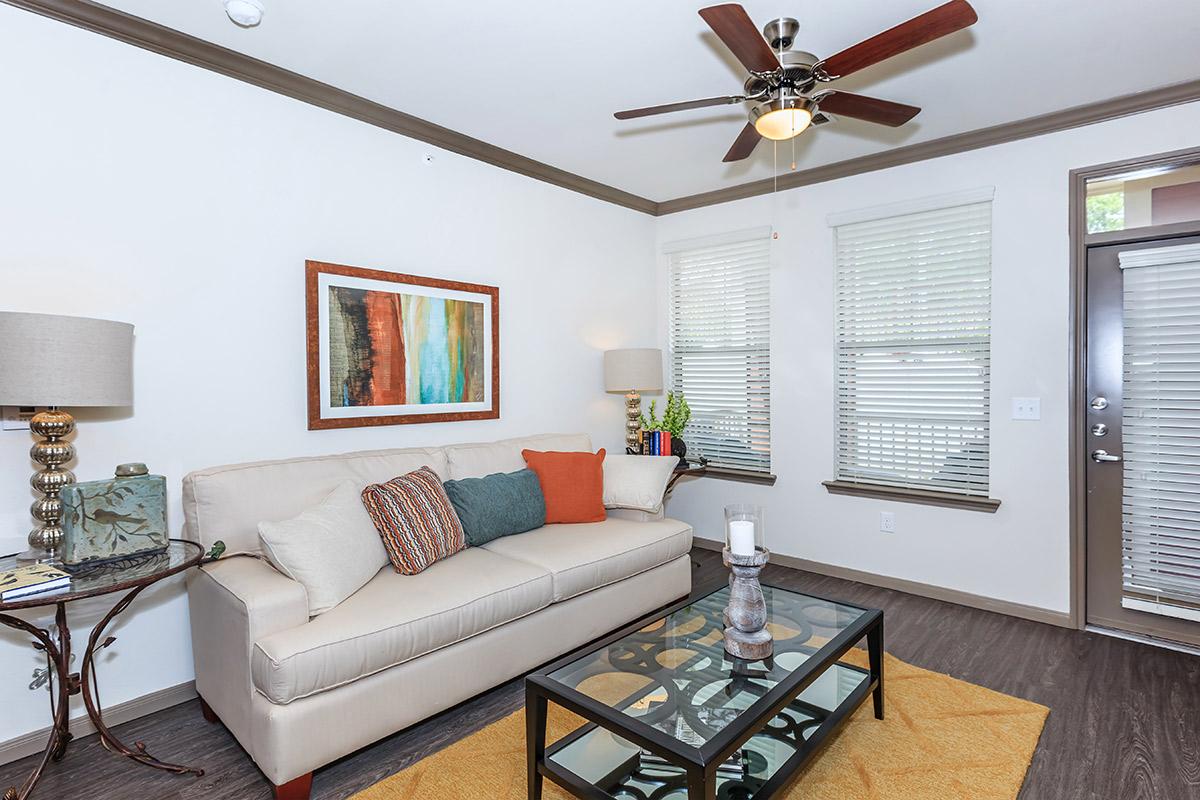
[658,80,1200,216]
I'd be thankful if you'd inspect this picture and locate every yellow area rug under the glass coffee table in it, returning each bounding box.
[354,650,1050,800]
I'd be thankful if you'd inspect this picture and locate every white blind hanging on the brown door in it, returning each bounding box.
[1121,245,1200,619]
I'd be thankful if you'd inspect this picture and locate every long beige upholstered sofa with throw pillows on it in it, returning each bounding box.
[184,434,691,798]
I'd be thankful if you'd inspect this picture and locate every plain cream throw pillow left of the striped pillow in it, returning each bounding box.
[258,481,388,616]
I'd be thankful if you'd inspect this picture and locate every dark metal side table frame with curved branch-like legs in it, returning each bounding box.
[0,540,204,800]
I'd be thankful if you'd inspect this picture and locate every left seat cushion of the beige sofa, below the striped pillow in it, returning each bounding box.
[251,540,553,703]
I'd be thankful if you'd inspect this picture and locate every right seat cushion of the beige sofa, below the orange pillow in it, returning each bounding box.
[482,518,691,602]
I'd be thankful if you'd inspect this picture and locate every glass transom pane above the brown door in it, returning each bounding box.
[1087,164,1200,234]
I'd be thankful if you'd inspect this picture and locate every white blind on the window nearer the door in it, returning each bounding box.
[835,199,991,497]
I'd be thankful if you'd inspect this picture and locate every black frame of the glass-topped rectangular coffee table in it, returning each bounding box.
[526,582,883,800]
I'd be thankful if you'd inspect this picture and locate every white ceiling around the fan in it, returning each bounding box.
[98,0,1200,200]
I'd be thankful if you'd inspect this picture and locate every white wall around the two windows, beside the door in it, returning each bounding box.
[658,103,1200,612]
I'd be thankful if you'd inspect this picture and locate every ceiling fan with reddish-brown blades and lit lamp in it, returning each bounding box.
[614,0,978,161]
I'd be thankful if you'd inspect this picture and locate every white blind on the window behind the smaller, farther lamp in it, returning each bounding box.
[666,229,770,473]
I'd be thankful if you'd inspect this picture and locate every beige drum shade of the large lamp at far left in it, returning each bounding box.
[0,311,133,407]
